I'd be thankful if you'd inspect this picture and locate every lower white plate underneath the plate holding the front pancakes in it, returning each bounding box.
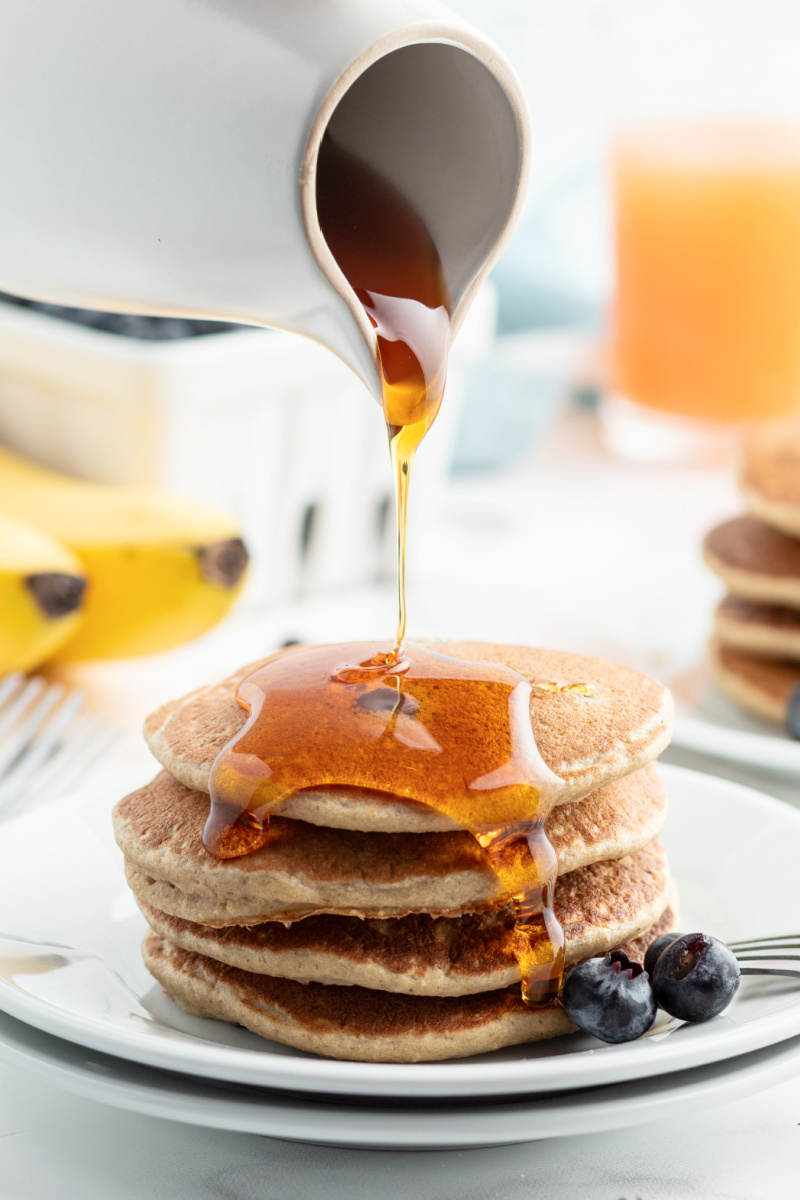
[0,1014,800,1150]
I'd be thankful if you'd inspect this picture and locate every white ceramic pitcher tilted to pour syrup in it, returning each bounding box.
[0,0,529,396]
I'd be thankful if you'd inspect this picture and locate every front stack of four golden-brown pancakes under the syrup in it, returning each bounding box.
[114,642,676,1062]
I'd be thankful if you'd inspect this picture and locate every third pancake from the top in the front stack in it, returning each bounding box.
[139,842,673,996]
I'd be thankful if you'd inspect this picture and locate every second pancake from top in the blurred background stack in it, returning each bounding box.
[703,517,800,608]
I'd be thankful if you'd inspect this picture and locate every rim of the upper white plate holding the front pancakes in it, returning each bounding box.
[0,763,800,1098]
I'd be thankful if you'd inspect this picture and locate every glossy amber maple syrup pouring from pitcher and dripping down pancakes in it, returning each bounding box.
[203,136,564,1004]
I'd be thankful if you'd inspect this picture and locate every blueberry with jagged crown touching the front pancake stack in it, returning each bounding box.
[561,950,656,1044]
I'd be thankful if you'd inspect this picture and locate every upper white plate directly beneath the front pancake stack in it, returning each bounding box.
[0,767,800,1098]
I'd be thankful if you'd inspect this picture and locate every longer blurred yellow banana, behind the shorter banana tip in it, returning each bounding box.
[0,448,247,662]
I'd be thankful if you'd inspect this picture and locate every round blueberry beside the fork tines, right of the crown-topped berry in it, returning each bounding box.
[652,934,740,1021]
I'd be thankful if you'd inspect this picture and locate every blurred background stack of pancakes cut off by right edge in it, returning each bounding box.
[703,421,800,737]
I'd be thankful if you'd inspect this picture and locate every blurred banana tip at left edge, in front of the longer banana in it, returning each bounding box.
[0,516,86,676]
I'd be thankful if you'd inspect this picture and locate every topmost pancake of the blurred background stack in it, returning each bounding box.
[739,420,800,538]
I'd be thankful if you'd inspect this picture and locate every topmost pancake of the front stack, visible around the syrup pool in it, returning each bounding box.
[144,642,673,833]
